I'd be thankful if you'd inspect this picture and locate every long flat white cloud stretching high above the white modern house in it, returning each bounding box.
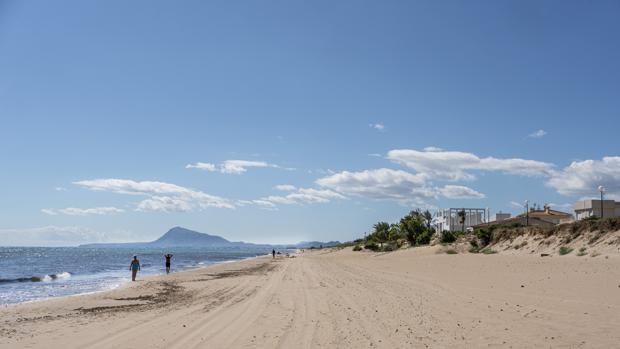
[387,149,554,181]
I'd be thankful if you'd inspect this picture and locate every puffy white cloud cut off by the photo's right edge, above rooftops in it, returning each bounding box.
[547,156,620,198]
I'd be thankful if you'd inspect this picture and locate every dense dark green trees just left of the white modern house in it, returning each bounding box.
[363,210,435,252]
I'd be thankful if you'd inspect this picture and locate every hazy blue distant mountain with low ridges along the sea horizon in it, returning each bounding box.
[79,227,340,249]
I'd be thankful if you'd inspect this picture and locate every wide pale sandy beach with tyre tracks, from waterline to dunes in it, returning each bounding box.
[0,247,620,349]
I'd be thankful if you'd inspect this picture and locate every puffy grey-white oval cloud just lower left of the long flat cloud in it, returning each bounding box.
[316,168,435,203]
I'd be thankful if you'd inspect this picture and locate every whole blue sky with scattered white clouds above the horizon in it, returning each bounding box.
[0,0,620,246]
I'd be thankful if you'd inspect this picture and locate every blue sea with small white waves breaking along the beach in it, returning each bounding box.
[0,247,270,304]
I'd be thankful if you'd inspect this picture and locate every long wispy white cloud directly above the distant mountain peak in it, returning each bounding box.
[74,178,234,211]
